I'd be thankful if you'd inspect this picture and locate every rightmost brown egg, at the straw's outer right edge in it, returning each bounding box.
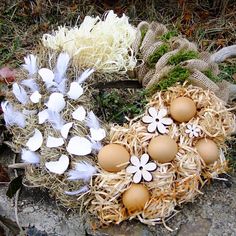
[196,138,219,165]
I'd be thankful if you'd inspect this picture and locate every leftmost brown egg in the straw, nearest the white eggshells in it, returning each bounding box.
[98,144,130,172]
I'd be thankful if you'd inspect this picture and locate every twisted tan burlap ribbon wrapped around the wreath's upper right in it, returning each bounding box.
[132,22,236,102]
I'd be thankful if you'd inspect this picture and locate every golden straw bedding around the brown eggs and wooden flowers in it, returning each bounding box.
[89,84,235,225]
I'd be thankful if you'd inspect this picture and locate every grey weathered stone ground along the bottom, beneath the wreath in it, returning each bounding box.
[0,149,236,236]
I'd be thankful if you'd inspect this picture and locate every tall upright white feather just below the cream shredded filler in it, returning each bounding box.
[54,53,70,84]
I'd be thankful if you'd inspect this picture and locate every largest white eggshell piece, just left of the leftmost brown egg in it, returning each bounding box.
[66,136,92,156]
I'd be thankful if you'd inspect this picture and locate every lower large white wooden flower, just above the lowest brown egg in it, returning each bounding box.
[126,154,157,183]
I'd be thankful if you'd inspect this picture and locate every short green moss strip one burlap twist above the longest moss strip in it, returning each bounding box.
[168,50,198,65]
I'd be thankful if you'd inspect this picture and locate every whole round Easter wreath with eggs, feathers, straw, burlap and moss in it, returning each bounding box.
[2,11,236,229]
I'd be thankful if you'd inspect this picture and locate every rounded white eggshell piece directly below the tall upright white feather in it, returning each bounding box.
[46,93,66,112]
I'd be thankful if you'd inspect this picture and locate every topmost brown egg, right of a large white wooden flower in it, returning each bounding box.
[170,97,197,122]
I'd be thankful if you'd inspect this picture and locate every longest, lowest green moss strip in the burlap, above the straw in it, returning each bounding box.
[147,66,190,96]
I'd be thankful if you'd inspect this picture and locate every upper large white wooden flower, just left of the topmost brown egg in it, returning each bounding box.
[142,107,173,134]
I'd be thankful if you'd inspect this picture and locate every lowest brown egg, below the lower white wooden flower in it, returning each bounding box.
[122,184,150,212]
